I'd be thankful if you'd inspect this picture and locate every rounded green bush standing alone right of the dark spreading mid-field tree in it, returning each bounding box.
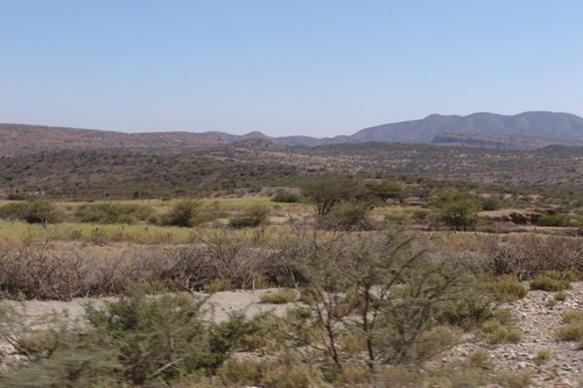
[431,191,482,231]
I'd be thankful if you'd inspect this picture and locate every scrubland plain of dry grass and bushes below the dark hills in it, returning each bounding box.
[0,175,583,387]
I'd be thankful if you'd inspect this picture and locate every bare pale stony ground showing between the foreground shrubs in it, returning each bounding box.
[1,283,583,388]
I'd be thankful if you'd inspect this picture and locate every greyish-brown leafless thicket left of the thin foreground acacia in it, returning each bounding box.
[0,231,302,300]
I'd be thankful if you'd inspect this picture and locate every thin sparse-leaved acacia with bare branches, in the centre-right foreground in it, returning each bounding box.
[288,232,480,370]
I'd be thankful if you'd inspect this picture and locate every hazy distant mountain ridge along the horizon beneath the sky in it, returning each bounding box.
[0,111,583,156]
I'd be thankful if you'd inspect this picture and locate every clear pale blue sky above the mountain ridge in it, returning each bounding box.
[0,0,583,136]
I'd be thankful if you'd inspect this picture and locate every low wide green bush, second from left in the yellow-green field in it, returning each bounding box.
[75,202,153,224]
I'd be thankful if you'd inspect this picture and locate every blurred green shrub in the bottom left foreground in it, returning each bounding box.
[0,291,254,387]
